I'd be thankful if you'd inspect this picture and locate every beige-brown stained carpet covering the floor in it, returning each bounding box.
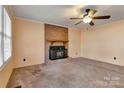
[7,58,124,88]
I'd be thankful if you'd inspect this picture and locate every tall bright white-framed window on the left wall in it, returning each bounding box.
[0,6,11,67]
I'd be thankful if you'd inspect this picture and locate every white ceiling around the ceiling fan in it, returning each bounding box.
[12,5,124,29]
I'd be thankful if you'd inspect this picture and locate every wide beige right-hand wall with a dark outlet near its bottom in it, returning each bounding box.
[81,20,124,66]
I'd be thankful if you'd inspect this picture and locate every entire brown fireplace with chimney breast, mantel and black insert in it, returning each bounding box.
[45,24,68,62]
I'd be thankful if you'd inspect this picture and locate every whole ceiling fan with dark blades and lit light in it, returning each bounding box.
[70,9,111,26]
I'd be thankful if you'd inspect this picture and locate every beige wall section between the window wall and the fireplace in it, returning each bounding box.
[13,18,45,68]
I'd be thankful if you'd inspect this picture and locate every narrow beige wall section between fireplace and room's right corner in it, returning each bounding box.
[68,28,81,58]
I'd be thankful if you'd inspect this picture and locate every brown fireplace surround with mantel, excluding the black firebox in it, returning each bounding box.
[45,24,69,62]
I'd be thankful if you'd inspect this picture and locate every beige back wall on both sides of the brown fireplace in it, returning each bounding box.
[13,18,81,68]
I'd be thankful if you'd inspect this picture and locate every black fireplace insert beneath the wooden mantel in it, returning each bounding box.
[49,46,68,60]
